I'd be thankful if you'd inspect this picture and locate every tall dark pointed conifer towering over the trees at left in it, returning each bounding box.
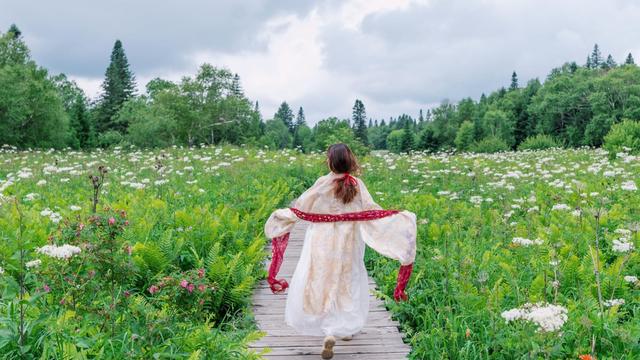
[96,40,136,133]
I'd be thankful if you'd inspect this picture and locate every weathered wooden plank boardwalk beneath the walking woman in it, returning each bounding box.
[250,222,410,360]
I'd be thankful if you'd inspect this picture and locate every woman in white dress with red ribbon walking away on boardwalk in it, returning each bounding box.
[265,144,416,359]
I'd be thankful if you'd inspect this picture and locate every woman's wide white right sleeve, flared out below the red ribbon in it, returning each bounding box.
[358,211,417,265]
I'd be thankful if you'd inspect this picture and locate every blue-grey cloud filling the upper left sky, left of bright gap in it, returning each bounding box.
[0,0,313,77]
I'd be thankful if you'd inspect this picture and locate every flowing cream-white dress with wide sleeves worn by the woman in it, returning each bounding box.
[265,172,416,336]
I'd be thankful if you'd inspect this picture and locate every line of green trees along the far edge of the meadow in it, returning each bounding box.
[0,25,640,153]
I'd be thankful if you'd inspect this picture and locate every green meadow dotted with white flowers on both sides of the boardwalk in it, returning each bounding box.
[0,147,640,359]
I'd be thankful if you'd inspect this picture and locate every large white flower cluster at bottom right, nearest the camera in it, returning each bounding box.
[501,303,568,332]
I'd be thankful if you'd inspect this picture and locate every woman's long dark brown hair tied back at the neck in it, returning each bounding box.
[327,144,360,204]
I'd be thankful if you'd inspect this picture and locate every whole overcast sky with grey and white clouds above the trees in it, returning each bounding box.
[0,0,640,123]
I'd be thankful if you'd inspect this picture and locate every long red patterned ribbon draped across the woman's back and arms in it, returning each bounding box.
[267,207,413,301]
